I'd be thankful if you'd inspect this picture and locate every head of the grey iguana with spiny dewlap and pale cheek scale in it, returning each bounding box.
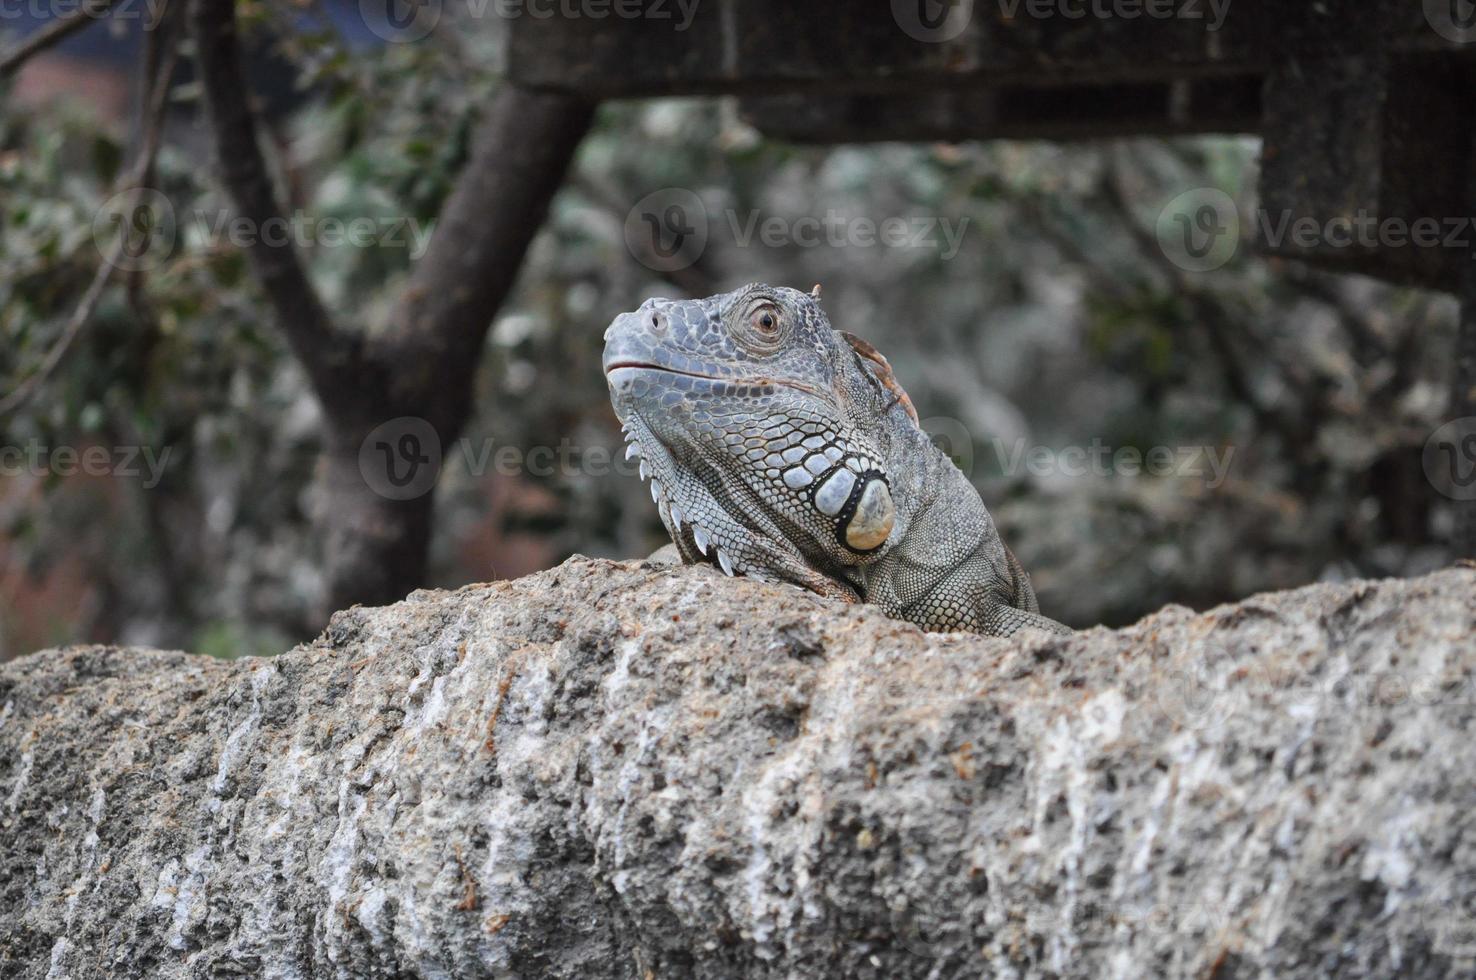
[604,283,915,590]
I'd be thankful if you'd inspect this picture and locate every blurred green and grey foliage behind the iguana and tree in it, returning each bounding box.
[0,0,1457,660]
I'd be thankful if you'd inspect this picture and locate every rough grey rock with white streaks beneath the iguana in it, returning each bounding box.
[0,558,1476,980]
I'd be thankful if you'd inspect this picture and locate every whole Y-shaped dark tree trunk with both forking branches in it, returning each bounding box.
[190,0,595,610]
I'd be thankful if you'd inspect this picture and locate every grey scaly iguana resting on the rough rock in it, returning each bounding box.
[604,283,1070,636]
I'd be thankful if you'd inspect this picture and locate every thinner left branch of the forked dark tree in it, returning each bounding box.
[192,0,363,415]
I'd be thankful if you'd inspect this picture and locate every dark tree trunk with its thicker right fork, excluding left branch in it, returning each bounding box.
[308,86,593,618]
